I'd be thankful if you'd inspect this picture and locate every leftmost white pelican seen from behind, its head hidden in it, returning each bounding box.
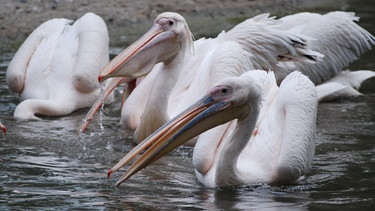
[6,13,113,119]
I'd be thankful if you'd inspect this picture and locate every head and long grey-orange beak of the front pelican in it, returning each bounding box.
[108,74,261,186]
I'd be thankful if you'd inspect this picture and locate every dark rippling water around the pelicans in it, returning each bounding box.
[0,0,375,210]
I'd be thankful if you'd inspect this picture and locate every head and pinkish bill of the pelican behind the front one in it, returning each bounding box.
[98,12,193,82]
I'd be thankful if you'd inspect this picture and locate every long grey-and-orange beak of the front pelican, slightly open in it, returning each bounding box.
[108,88,249,186]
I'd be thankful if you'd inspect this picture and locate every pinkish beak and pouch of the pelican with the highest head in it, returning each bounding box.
[98,23,181,82]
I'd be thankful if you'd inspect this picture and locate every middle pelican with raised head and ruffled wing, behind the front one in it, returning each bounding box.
[81,12,321,141]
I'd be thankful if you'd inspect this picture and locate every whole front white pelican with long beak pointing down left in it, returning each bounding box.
[108,71,318,187]
